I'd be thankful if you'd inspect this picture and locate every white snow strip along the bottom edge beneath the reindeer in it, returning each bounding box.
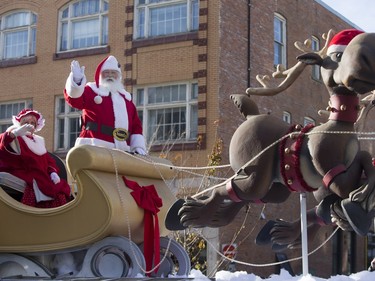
[189,269,375,281]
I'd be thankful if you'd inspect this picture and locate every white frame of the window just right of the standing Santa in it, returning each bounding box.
[134,82,198,145]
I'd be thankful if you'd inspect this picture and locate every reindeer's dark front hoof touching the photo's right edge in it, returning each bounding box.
[341,199,375,236]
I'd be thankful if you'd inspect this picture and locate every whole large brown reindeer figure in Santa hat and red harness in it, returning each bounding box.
[166,30,375,245]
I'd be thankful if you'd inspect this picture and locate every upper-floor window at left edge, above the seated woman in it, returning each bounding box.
[0,11,37,60]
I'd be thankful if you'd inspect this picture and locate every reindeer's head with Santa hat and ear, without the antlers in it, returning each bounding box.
[297,29,375,95]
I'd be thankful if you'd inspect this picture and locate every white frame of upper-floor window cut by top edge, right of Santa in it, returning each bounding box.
[134,0,199,39]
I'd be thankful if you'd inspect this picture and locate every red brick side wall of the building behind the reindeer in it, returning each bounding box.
[218,0,363,277]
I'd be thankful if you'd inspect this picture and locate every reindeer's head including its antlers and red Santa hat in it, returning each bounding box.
[246,29,375,96]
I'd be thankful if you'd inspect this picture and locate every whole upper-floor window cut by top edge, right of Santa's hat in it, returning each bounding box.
[135,0,199,39]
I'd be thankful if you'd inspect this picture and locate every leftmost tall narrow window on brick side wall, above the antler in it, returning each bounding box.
[273,14,286,67]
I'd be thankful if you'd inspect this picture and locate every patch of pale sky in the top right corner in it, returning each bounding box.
[321,0,375,32]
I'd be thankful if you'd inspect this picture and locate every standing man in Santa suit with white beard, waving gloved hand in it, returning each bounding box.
[64,56,146,155]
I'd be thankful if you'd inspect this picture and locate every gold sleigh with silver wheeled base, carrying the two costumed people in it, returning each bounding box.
[0,145,190,277]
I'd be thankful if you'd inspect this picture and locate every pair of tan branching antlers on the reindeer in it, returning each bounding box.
[246,29,334,96]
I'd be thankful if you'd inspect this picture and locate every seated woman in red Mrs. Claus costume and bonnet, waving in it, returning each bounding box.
[0,109,71,208]
